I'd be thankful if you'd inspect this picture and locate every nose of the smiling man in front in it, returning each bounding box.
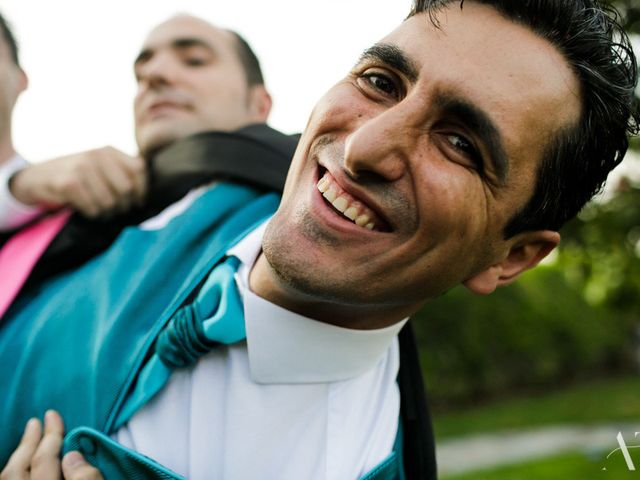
[344,110,417,182]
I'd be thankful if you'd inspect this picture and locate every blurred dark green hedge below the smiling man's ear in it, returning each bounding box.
[413,267,628,406]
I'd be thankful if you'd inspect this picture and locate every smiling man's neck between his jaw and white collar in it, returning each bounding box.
[249,253,415,330]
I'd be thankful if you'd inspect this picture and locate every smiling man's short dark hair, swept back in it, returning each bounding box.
[409,0,640,238]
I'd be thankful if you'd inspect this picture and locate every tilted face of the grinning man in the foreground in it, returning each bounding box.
[263,2,580,326]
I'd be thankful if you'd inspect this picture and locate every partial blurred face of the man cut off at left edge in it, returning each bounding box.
[0,34,27,140]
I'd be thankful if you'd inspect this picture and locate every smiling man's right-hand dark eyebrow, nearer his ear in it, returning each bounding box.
[436,95,509,183]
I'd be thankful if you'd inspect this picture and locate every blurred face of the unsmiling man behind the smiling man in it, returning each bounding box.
[134,16,252,153]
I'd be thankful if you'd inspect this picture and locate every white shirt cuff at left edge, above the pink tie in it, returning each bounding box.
[0,155,42,232]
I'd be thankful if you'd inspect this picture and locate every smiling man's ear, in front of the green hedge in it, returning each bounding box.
[463,230,560,295]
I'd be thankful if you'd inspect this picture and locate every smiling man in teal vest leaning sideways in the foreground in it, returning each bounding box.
[0,0,637,480]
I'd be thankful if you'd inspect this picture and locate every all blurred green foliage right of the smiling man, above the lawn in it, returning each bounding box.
[414,0,640,406]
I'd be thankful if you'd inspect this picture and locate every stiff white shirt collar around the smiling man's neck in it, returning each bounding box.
[227,221,407,383]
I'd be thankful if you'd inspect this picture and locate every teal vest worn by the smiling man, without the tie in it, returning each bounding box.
[0,184,404,480]
